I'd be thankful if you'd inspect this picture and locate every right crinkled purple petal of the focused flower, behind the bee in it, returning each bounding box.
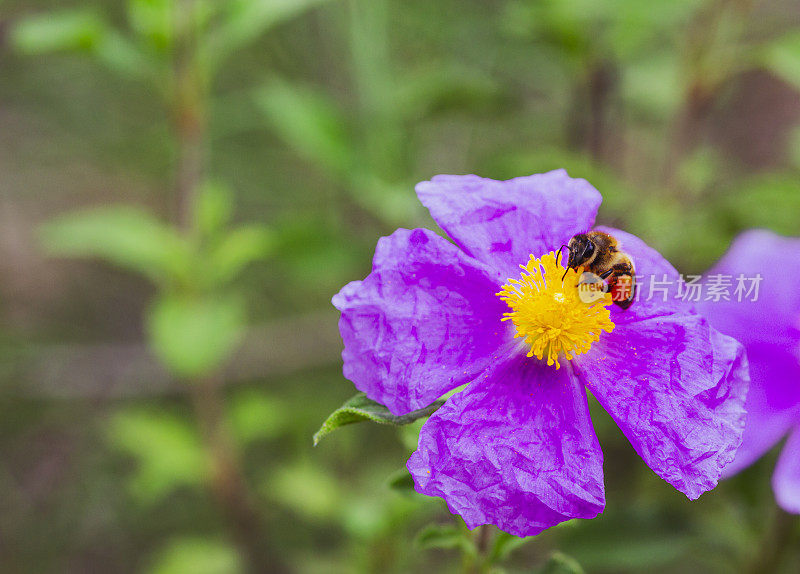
[574,230,749,499]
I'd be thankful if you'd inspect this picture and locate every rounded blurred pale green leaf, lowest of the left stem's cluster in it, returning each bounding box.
[147,295,245,378]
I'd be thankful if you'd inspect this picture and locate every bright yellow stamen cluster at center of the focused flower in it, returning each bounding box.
[497,252,614,369]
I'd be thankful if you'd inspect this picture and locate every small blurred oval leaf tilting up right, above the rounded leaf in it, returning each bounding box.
[208,225,274,284]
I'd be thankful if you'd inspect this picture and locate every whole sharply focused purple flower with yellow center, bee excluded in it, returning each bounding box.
[333,170,747,536]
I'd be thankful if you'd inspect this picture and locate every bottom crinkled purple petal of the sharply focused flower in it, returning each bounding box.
[408,355,605,536]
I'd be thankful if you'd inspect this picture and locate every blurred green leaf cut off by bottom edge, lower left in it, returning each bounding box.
[148,538,245,574]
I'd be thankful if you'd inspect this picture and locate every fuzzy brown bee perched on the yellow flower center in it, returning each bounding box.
[559,231,636,309]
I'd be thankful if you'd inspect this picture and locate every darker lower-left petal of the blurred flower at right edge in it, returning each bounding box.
[723,344,800,477]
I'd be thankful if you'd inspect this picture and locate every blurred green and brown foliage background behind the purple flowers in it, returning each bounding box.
[0,0,800,574]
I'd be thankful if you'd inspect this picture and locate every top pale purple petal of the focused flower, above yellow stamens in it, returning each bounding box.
[416,169,601,277]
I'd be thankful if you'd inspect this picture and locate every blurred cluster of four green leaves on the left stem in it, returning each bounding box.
[41,184,272,378]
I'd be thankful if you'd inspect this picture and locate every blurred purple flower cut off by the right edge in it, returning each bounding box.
[700,230,800,513]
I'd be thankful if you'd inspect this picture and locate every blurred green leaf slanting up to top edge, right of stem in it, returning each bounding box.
[206,0,334,65]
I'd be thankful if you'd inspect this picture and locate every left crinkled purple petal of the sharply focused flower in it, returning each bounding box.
[333,229,513,415]
